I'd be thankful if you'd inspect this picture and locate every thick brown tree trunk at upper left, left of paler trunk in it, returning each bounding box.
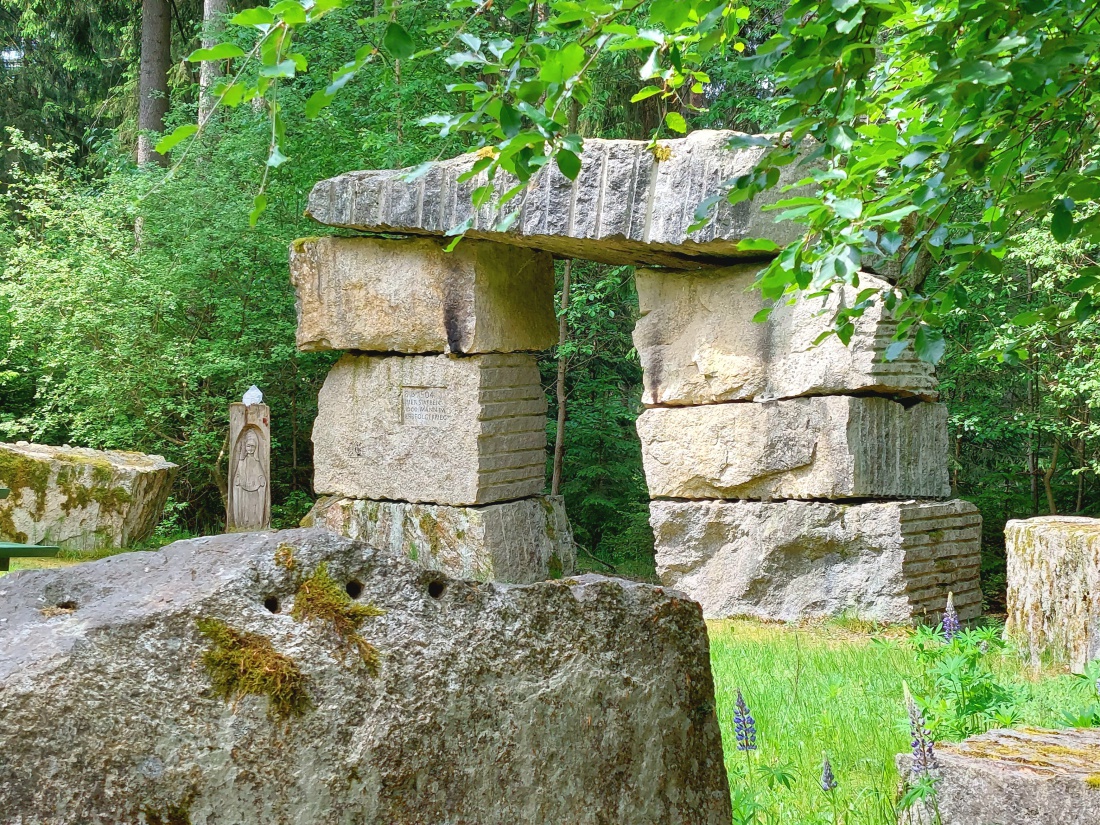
[138,0,172,165]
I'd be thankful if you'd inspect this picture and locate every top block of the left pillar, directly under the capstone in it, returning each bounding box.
[290,238,558,353]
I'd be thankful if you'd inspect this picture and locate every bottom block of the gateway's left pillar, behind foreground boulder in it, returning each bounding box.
[303,496,576,584]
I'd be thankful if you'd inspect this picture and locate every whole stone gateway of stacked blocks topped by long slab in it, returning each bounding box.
[292,132,981,622]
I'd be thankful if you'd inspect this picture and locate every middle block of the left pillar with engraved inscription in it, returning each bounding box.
[314,354,547,505]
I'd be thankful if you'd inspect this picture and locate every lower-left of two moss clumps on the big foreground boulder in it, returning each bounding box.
[197,618,312,722]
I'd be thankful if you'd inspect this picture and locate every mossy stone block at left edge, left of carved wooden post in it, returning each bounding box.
[0,441,177,550]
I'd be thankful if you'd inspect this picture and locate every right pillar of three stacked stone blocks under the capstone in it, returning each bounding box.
[634,264,981,623]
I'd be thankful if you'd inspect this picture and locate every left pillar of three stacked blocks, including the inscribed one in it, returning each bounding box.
[290,238,574,582]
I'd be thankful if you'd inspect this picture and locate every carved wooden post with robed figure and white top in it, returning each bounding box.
[226,387,272,532]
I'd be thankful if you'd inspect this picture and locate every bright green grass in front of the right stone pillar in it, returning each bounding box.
[710,620,1089,825]
